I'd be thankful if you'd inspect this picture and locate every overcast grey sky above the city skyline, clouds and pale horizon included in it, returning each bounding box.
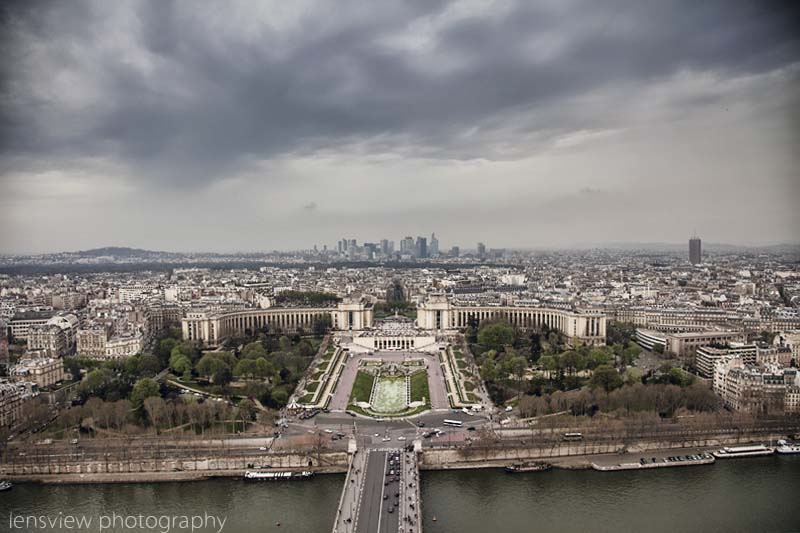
[0,0,800,252]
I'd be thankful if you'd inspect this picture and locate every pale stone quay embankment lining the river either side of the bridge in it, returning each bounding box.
[0,434,782,484]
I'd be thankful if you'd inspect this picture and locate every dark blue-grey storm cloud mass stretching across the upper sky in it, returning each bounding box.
[0,0,800,185]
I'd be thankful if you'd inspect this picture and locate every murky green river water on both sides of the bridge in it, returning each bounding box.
[0,457,800,533]
